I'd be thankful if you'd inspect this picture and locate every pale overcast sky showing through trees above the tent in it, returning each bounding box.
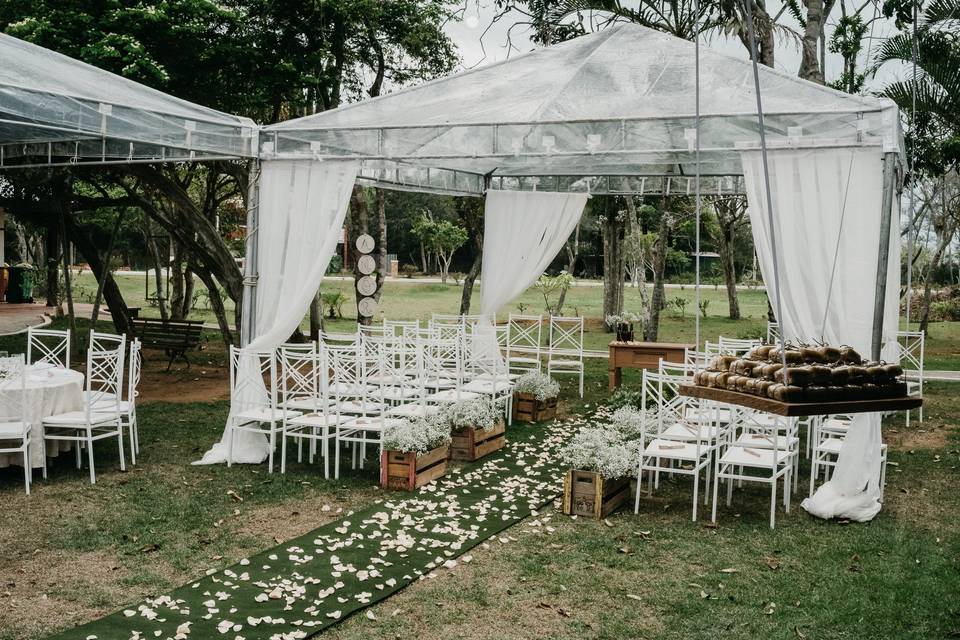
[447,0,901,92]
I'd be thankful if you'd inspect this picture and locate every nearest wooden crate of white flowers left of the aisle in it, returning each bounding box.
[380,416,450,491]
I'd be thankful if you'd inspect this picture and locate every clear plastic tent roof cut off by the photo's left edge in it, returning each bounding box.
[0,34,256,168]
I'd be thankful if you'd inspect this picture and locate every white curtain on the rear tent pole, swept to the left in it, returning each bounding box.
[480,190,590,316]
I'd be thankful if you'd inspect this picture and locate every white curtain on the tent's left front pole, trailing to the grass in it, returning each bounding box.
[197,160,359,464]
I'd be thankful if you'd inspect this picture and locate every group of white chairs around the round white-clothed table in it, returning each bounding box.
[0,329,142,494]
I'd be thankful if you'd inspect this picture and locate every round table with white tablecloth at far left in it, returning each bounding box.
[0,364,83,469]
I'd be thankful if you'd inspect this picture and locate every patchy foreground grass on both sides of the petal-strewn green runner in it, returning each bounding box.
[0,316,960,640]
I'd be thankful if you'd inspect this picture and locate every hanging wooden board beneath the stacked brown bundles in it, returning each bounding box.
[680,384,923,416]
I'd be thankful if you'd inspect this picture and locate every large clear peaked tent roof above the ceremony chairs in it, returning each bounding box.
[260,24,901,193]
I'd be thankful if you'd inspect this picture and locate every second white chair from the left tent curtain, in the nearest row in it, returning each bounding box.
[280,346,339,478]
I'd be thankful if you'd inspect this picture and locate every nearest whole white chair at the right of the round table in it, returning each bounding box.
[43,338,127,484]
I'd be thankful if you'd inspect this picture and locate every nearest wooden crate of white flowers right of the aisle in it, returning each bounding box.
[561,407,642,520]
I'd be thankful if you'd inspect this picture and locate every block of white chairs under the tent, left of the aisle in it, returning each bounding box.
[228,318,556,477]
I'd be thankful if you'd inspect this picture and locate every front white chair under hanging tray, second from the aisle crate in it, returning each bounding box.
[713,404,795,529]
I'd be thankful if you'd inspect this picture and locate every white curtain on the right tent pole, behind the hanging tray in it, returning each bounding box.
[741,147,900,520]
